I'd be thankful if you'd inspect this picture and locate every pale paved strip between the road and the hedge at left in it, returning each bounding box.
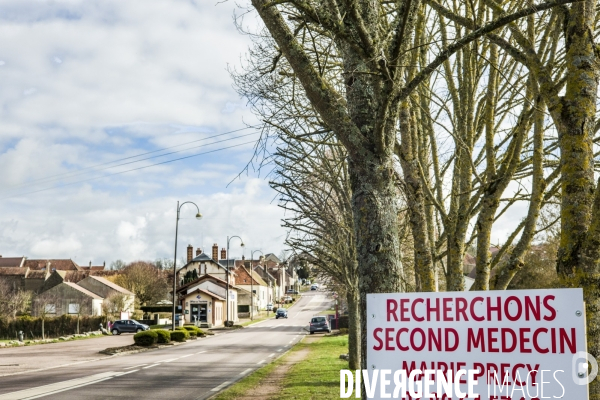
[0,334,133,377]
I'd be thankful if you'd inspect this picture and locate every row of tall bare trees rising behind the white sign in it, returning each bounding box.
[233,0,600,399]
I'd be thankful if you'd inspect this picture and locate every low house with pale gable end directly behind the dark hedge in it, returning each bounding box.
[32,282,103,317]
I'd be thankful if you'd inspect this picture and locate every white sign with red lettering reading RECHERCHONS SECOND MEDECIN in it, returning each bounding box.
[367,289,588,400]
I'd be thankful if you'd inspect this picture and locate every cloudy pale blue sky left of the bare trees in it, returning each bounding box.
[0,0,285,265]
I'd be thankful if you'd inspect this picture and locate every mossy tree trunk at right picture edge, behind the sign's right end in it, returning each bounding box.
[552,0,600,400]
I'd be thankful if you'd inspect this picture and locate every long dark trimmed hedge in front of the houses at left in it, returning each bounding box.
[0,315,106,339]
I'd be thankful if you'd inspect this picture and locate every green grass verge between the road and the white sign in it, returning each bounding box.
[211,336,348,400]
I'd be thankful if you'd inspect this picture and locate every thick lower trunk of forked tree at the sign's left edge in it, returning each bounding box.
[349,155,402,369]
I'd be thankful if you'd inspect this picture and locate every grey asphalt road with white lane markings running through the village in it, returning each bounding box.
[0,292,331,400]
